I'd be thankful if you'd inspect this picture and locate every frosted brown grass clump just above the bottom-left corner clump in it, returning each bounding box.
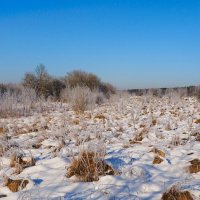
[10,153,35,174]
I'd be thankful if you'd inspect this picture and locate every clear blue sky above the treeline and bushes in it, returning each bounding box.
[0,0,200,88]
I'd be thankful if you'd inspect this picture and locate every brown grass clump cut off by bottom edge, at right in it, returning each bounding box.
[161,186,193,200]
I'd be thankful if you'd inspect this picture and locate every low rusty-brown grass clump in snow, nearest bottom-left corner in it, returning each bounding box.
[4,177,29,192]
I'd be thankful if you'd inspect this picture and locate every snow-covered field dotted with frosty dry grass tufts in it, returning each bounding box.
[0,95,200,200]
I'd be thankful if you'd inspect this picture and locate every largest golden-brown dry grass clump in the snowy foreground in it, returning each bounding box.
[66,151,115,182]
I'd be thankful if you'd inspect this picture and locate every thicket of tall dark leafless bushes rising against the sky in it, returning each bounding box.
[22,67,115,100]
